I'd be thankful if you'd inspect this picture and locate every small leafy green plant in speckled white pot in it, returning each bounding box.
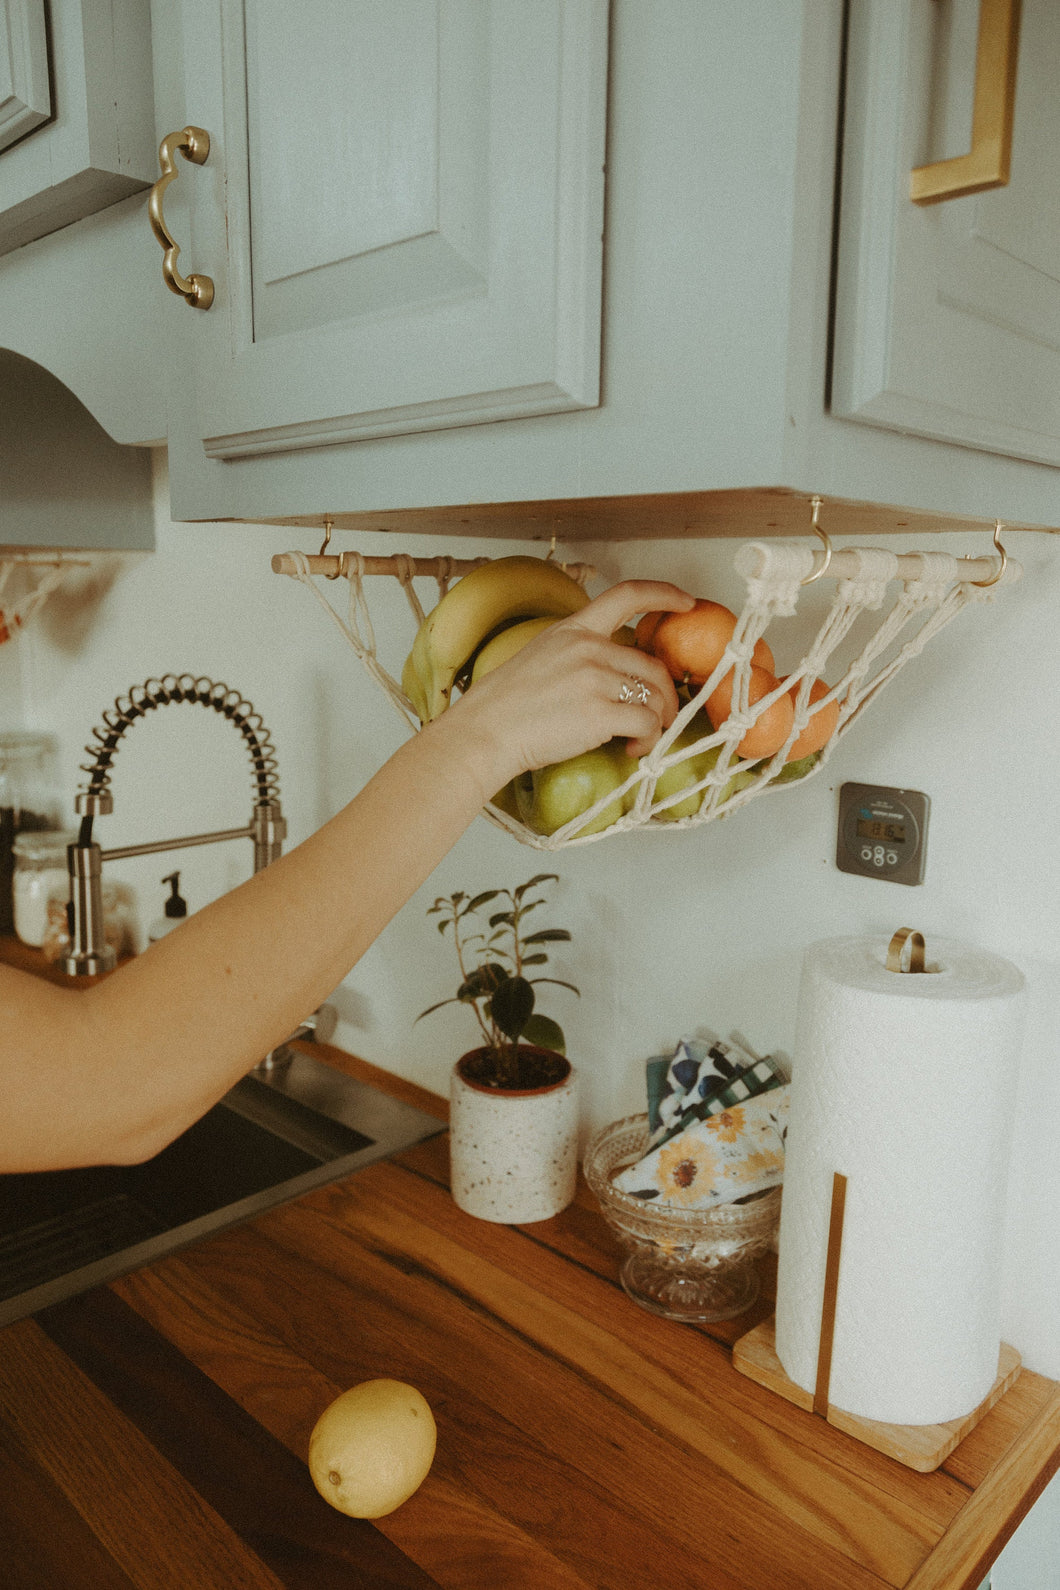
[416,873,578,1224]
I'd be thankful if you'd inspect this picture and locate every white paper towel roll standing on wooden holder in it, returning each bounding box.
[776,938,1023,1425]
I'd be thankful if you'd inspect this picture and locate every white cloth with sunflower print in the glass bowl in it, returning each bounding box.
[615,1083,791,1208]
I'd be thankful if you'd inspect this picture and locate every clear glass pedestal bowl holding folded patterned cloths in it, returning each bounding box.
[583,1115,780,1323]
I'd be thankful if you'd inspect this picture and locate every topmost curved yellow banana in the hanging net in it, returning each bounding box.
[402,557,588,723]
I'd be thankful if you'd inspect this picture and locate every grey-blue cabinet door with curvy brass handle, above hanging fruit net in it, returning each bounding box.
[156,0,607,489]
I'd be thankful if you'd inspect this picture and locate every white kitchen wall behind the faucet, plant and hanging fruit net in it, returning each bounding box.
[8,455,1060,1375]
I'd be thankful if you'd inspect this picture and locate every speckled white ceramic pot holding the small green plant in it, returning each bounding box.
[450,1051,578,1226]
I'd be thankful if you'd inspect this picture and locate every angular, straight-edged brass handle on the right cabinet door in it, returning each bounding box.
[909,0,1020,204]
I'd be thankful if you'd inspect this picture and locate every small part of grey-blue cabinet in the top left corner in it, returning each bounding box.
[0,0,156,253]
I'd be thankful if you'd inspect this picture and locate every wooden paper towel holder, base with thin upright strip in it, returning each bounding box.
[733,1172,1022,1474]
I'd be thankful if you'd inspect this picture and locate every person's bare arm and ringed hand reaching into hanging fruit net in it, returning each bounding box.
[0,582,691,1170]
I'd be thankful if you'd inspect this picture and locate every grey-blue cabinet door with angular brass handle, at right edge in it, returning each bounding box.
[831,0,1060,464]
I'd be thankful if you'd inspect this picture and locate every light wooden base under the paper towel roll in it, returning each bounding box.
[733,1320,1022,1474]
